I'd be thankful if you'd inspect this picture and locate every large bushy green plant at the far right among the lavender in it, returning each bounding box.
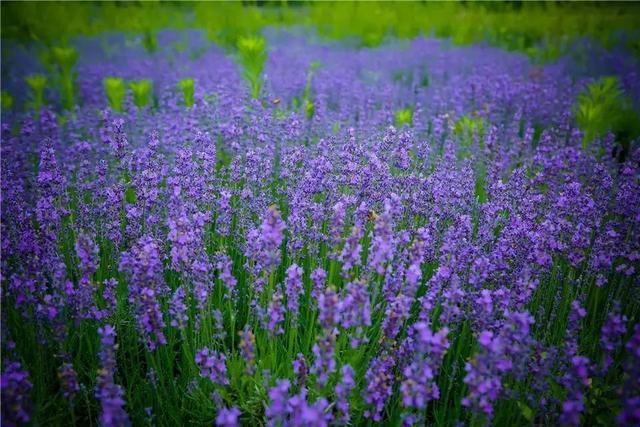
[575,77,640,149]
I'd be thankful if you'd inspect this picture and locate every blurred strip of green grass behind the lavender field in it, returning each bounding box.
[1,1,640,61]
